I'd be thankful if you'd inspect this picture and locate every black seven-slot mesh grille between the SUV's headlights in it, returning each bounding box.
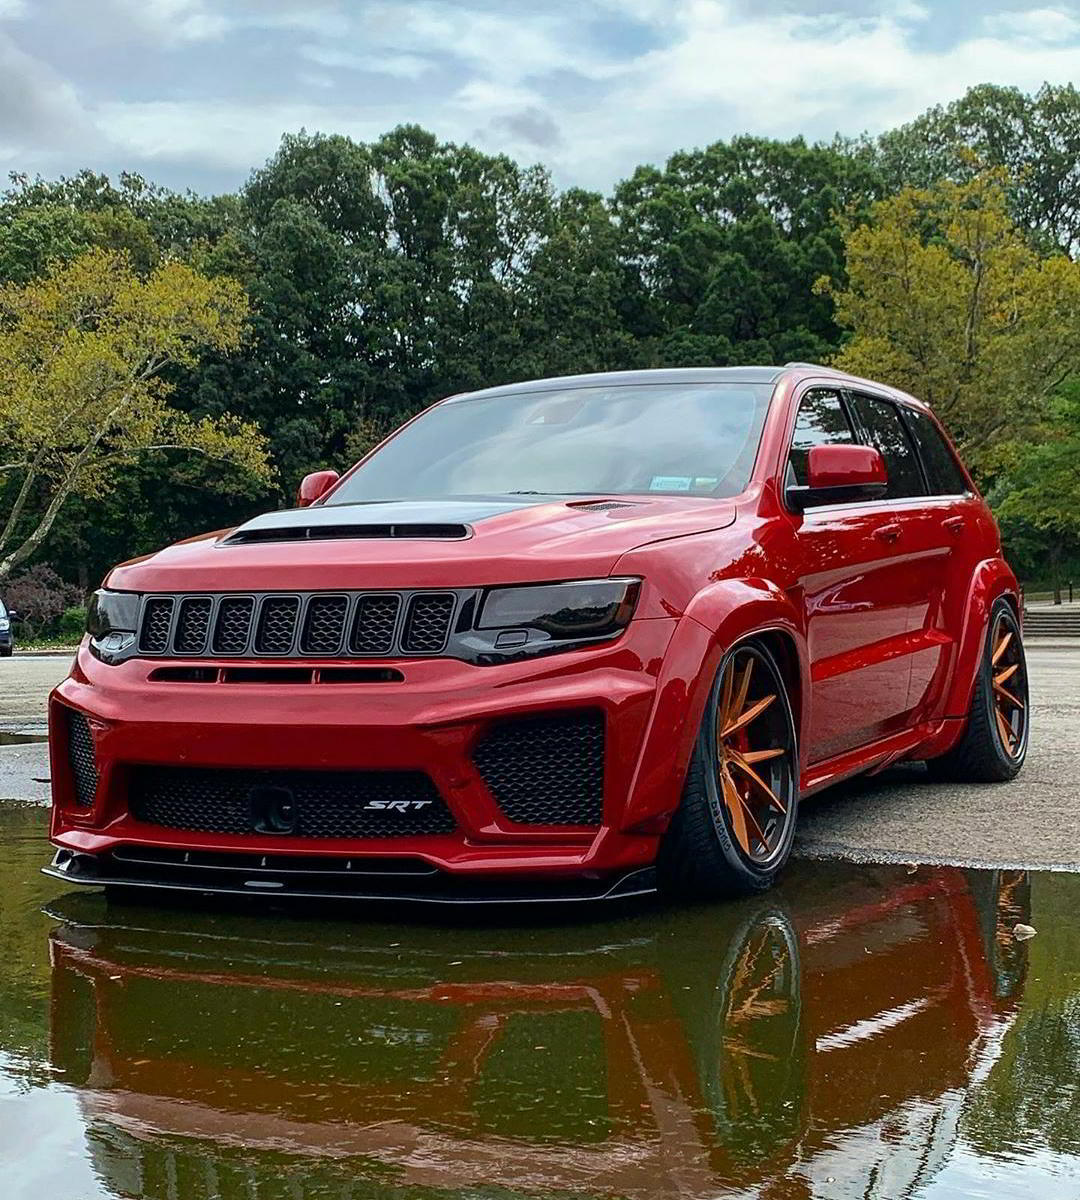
[138,592,458,659]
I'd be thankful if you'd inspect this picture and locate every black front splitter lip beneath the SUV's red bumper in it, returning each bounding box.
[42,850,656,905]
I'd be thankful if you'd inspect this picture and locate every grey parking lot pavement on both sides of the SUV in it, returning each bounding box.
[0,638,1080,870]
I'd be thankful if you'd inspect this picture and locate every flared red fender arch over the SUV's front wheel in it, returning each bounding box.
[619,578,810,833]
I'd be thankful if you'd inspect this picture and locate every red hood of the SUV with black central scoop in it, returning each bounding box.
[108,496,736,592]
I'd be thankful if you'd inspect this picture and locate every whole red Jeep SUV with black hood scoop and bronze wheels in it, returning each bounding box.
[47,364,1028,901]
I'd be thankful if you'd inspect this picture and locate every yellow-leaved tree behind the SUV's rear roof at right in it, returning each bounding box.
[820,170,1080,479]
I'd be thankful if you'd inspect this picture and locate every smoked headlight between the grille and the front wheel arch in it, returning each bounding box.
[476,578,641,641]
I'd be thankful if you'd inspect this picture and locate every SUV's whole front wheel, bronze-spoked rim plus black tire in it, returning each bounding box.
[656,641,799,899]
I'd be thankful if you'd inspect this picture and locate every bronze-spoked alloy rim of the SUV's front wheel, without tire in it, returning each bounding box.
[713,646,796,866]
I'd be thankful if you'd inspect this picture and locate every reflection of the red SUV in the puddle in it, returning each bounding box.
[52,866,1028,1200]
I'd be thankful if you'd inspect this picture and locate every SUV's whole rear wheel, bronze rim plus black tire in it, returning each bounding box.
[926,600,1030,784]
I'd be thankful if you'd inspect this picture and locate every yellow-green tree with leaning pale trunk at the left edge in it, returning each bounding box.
[0,250,269,580]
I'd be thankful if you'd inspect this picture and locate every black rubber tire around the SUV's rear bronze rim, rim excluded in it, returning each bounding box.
[926,599,1031,784]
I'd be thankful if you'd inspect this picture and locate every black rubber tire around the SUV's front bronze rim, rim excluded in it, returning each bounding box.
[656,641,798,900]
